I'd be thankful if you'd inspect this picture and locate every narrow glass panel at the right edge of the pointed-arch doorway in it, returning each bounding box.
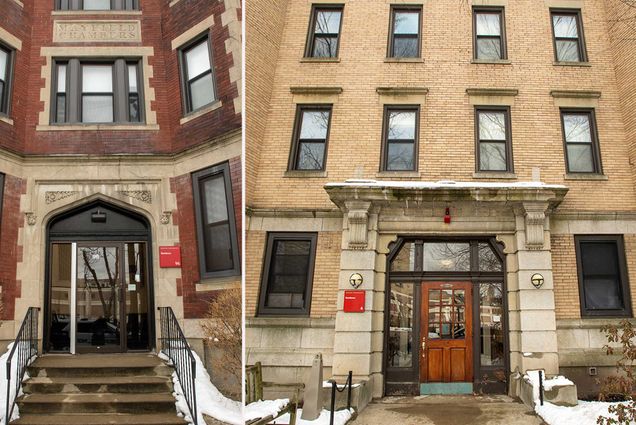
[124,243,148,350]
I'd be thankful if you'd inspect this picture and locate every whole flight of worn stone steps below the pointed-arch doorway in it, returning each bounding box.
[12,353,187,425]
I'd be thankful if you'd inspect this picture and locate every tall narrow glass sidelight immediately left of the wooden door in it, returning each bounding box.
[388,283,413,367]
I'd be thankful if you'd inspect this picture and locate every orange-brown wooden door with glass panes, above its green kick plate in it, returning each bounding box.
[420,282,473,383]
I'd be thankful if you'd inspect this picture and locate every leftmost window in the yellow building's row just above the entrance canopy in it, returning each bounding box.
[289,105,331,171]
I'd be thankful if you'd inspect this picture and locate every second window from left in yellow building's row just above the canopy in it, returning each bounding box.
[381,106,420,171]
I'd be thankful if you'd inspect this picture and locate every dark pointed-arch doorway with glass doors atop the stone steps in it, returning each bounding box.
[44,200,154,354]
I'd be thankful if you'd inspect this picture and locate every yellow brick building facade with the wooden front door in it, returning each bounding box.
[245,0,636,397]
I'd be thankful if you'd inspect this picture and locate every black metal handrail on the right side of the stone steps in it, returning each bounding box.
[158,307,198,425]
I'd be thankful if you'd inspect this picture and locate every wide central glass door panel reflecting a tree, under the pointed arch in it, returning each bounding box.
[76,246,122,351]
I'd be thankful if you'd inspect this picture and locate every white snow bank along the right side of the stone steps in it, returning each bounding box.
[159,351,245,425]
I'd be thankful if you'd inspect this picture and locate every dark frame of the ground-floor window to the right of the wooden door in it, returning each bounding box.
[574,235,633,319]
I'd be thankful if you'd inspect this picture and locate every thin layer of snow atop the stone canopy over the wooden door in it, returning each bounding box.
[325,179,567,189]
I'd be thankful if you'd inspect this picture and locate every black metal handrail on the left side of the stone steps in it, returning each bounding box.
[4,307,40,424]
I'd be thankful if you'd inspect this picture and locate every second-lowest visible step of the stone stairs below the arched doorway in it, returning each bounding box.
[18,392,176,415]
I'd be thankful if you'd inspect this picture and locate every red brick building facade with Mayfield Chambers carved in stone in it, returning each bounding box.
[0,0,242,388]
